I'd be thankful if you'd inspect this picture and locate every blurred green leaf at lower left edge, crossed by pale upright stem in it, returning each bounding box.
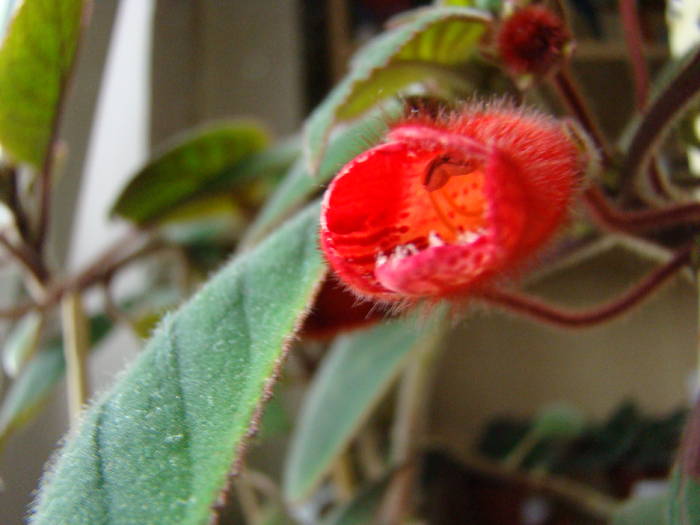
[0,315,112,448]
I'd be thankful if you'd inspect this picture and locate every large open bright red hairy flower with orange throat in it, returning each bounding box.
[321,104,583,302]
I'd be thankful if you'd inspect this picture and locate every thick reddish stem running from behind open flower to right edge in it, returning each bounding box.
[583,185,700,233]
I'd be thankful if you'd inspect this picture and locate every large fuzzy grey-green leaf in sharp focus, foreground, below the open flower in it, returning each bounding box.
[31,205,325,525]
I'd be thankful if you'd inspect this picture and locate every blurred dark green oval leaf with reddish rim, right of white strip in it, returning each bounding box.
[112,122,267,224]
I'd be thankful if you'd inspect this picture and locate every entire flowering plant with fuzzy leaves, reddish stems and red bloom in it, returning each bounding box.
[0,0,700,525]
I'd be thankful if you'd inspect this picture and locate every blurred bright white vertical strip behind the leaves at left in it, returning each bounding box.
[68,0,154,269]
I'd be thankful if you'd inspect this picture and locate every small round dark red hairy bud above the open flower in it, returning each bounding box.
[497,5,569,75]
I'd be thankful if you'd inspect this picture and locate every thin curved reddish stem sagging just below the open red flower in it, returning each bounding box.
[481,247,691,328]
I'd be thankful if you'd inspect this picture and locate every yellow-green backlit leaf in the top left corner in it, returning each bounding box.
[0,0,90,168]
